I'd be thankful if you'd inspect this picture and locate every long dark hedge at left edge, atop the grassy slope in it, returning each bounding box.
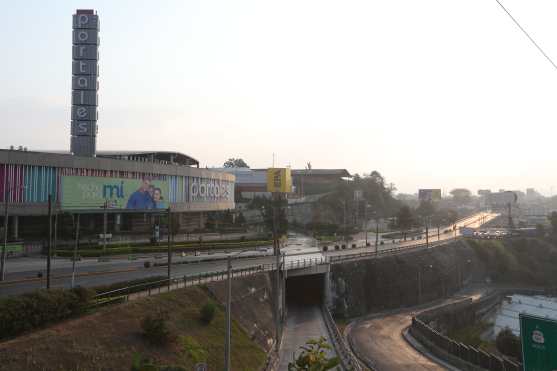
[0,287,92,339]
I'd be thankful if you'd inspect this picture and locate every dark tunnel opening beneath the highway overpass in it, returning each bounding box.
[286,274,326,307]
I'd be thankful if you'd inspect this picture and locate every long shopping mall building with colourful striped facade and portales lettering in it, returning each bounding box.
[0,149,235,239]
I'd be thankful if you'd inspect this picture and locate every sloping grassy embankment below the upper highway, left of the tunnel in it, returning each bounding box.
[0,287,266,371]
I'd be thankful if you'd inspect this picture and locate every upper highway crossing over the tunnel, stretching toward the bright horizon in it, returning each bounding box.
[0,213,496,296]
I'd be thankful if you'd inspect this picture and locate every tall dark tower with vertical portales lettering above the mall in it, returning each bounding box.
[70,9,99,157]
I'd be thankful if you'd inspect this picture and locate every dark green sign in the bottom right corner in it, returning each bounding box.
[519,314,557,371]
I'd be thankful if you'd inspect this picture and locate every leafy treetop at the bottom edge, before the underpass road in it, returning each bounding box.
[288,337,340,371]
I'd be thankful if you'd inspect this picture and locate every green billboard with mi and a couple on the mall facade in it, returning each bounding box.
[60,176,169,210]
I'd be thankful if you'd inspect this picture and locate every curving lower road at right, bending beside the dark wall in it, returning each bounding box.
[346,288,486,371]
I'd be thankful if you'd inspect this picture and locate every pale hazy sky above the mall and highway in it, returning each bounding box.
[0,0,557,194]
